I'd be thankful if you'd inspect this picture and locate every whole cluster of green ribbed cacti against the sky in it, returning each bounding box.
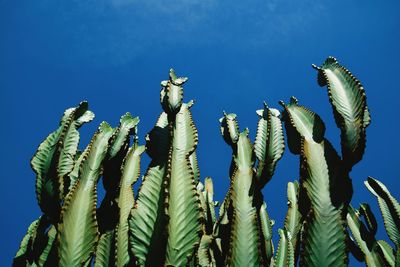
[13,57,400,266]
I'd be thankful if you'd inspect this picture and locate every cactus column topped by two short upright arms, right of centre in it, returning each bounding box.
[217,101,284,266]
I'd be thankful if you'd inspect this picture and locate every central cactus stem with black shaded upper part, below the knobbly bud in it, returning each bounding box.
[129,112,170,266]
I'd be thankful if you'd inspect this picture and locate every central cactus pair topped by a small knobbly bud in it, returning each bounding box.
[130,69,202,266]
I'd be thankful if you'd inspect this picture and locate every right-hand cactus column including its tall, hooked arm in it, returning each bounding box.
[281,57,370,266]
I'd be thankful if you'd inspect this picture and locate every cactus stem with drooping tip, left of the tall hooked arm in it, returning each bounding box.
[284,98,351,266]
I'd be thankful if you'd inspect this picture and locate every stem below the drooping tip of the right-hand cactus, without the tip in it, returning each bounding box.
[301,141,347,266]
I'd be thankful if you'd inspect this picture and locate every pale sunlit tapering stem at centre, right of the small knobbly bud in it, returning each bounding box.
[166,103,202,266]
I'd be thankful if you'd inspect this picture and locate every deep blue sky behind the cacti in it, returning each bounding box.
[0,0,400,266]
